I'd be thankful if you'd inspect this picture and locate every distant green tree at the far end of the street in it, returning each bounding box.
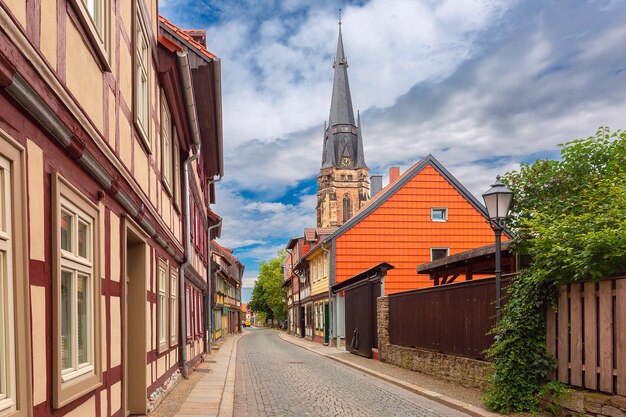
[248,250,287,321]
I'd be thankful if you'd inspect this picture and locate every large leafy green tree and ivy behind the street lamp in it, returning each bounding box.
[485,127,626,412]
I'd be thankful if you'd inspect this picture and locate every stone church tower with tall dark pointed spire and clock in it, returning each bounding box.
[317,19,370,227]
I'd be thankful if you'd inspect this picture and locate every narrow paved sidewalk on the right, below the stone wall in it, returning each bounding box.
[280,332,501,417]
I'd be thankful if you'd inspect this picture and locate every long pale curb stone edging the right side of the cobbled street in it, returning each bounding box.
[278,332,502,417]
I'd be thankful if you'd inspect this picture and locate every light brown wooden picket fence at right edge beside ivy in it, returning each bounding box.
[547,277,626,395]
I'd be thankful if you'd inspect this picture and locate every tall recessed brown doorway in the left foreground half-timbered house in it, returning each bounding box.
[122,223,148,416]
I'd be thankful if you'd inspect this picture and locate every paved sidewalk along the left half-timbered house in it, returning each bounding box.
[151,331,247,417]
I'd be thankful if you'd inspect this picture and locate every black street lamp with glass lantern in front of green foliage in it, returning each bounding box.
[483,175,513,324]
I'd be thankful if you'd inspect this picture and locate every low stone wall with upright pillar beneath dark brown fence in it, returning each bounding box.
[378,297,491,388]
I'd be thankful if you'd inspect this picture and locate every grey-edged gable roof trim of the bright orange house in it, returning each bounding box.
[324,155,498,242]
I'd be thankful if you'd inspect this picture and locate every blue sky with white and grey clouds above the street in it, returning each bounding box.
[159,0,626,300]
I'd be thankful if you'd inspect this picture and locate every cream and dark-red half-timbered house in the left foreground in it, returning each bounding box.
[0,0,223,417]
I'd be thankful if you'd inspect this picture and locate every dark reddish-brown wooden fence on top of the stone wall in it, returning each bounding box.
[389,278,508,359]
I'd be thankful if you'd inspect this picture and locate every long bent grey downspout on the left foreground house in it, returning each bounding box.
[176,52,202,378]
